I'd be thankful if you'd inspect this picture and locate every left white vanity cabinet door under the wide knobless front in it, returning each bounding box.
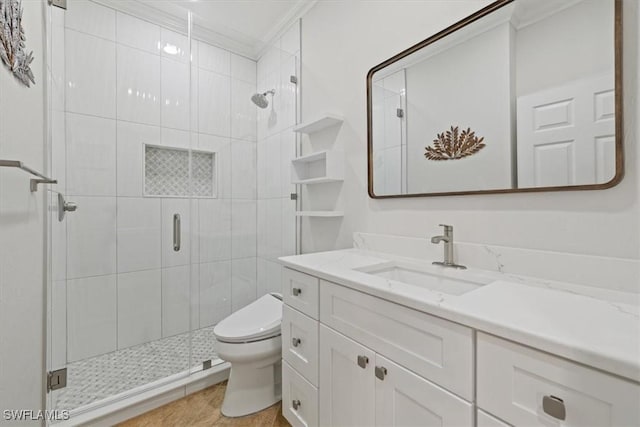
[319,325,375,427]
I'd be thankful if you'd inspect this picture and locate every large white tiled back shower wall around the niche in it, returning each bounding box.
[51,1,257,367]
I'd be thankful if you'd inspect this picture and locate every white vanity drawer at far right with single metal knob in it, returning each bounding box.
[477,333,640,427]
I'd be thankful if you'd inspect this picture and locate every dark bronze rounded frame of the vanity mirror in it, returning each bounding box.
[367,0,624,199]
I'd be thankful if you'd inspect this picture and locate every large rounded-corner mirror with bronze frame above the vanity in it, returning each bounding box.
[367,0,623,198]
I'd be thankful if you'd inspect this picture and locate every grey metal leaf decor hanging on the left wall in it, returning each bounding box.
[0,0,36,87]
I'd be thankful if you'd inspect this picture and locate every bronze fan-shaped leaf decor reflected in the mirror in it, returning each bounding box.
[424,126,485,160]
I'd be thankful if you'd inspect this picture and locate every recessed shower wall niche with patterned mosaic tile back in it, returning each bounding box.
[144,144,217,198]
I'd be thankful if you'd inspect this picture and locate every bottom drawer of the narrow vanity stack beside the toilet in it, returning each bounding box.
[282,362,318,427]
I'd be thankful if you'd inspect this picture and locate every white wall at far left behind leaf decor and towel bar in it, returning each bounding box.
[0,1,47,425]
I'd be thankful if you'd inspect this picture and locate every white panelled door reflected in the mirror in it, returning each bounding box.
[517,76,616,188]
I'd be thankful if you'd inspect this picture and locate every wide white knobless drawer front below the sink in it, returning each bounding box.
[320,281,474,401]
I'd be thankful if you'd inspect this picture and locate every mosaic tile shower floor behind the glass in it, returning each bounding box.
[53,326,217,410]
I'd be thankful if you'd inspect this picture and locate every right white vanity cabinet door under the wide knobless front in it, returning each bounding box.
[375,354,473,427]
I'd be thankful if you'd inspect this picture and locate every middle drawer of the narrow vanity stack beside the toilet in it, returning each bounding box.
[282,305,318,387]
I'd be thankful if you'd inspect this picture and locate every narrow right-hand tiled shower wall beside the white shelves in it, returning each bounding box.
[258,21,300,296]
